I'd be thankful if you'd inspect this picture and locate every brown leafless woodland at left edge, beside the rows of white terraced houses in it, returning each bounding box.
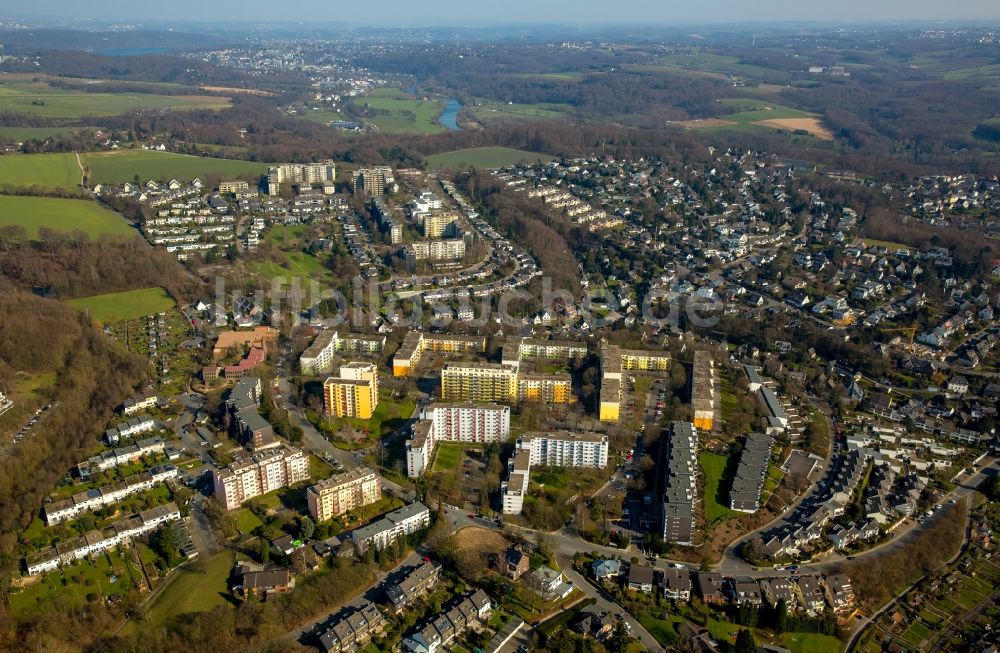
[0,280,146,650]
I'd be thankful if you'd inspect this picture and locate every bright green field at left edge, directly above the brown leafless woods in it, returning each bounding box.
[0,195,136,240]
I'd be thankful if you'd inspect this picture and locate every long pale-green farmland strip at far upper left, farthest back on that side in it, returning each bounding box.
[0,77,231,118]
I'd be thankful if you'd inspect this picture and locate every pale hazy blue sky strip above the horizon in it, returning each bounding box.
[17,0,1000,27]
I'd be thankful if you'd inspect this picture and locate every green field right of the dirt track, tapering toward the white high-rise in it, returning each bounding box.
[82,150,268,185]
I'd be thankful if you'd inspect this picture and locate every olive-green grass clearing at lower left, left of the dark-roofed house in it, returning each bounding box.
[126,551,233,632]
